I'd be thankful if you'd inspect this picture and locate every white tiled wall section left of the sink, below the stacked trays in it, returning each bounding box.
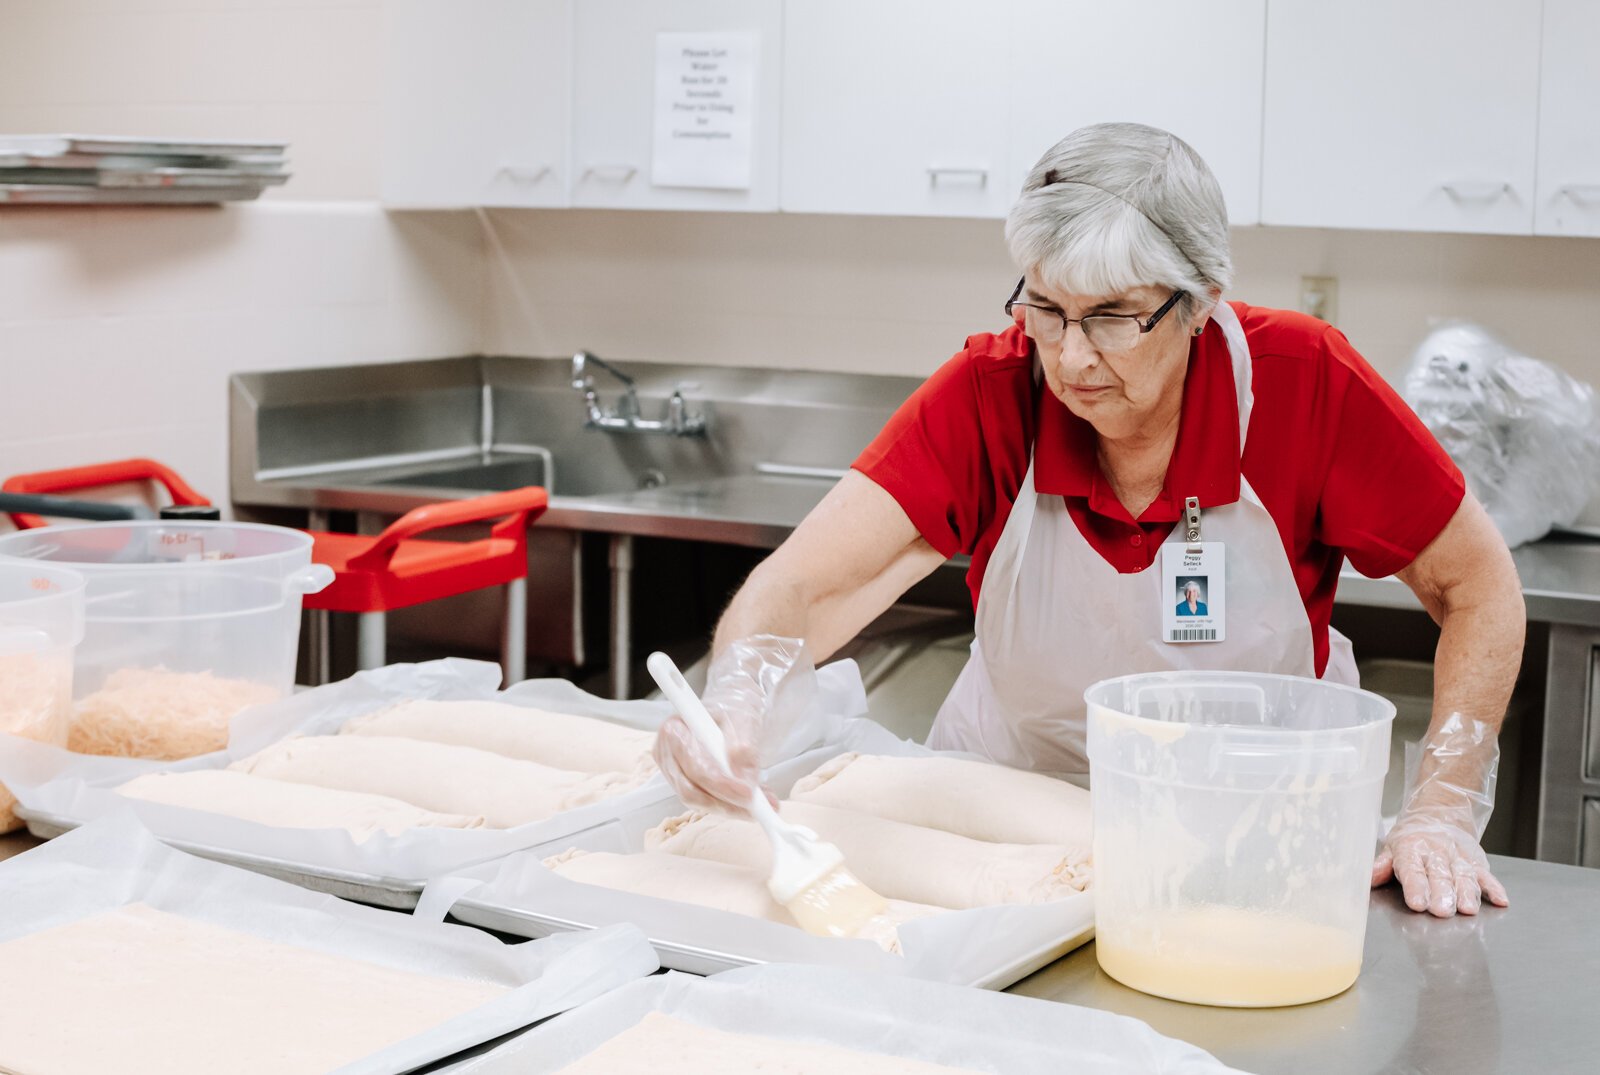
[0,202,486,515]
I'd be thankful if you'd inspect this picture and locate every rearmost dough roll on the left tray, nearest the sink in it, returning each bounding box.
[341,701,656,773]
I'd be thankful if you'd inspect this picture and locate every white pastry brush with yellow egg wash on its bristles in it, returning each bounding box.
[645,653,888,937]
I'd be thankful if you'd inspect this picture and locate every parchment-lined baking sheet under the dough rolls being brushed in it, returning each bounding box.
[416,720,1094,989]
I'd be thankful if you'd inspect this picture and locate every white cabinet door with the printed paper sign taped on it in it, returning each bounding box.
[571,0,782,211]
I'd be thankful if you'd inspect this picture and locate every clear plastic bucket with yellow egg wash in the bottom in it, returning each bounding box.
[1083,672,1395,1008]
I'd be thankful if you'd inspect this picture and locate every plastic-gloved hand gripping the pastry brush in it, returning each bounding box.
[654,635,811,814]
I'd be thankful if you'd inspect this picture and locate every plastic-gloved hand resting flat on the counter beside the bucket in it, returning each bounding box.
[1373,713,1509,918]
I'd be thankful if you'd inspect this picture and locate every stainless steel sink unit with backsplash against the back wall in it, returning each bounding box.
[229,355,918,696]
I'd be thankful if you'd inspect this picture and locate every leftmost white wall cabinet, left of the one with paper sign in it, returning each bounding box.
[381,0,573,208]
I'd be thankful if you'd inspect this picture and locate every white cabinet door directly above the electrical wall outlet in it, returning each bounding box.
[1261,0,1541,234]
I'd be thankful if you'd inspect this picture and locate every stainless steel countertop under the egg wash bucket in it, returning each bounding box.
[1008,856,1600,1075]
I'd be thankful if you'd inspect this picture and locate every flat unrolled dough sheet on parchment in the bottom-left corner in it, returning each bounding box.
[0,904,507,1075]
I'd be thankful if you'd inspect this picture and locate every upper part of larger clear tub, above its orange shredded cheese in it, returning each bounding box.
[0,520,333,757]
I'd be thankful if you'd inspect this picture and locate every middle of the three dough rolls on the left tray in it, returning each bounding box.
[229,736,648,829]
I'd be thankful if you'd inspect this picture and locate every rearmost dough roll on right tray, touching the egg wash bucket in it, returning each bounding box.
[789,753,1091,848]
